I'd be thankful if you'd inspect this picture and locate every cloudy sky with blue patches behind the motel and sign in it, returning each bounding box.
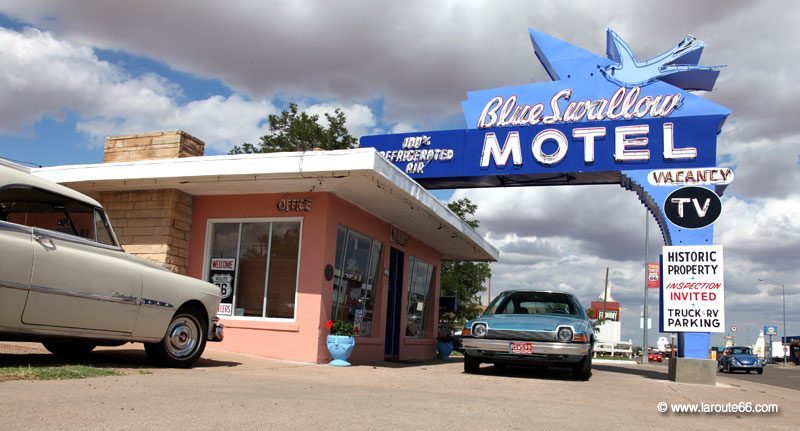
[0,0,800,345]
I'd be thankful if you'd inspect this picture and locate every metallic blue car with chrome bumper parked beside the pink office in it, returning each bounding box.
[461,290,594,380]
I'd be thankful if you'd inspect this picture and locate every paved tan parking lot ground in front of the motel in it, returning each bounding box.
[0,344,800,430]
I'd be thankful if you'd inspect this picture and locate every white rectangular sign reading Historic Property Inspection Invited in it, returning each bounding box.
[661,245,725,332]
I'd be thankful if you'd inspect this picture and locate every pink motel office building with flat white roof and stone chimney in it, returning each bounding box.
[32,131,498,363]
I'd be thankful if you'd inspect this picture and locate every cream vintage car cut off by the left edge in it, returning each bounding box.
[0,160,223,367]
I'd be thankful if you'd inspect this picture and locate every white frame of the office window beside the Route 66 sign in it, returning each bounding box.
[203,217,304,323]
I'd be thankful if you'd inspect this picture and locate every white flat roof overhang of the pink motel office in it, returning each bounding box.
[31,148,500,261]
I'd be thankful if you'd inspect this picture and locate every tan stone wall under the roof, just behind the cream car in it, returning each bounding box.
[97,189,193,274]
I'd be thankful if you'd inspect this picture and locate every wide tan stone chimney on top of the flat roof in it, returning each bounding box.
[103,130,206,163]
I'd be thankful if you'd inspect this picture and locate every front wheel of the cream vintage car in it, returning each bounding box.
[144,307,206,368]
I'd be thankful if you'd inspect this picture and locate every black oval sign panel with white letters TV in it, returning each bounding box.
[664,187,722,229]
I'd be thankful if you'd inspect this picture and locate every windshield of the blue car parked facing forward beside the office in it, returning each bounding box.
[483,292,583,317]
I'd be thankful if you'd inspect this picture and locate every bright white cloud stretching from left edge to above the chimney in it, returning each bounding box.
[0,28,276,152]
